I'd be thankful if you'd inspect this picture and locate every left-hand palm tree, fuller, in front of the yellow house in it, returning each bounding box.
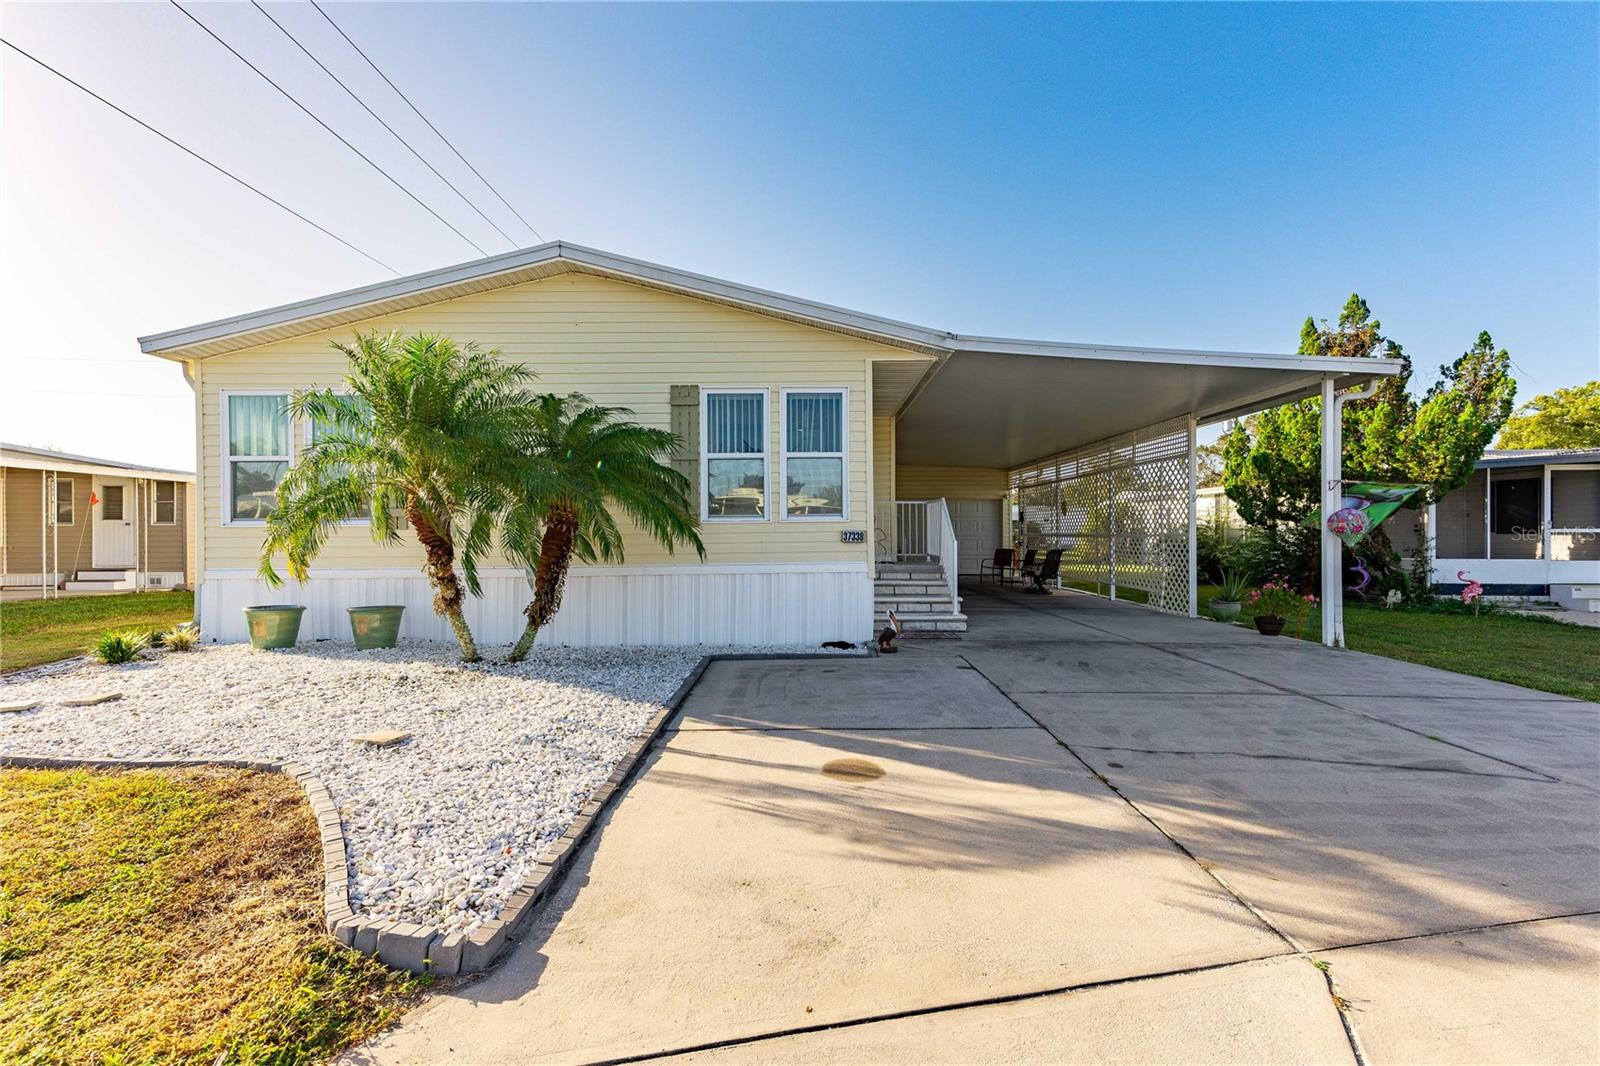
[259,333,534,663]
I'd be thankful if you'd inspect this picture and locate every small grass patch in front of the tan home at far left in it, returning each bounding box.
[0,591,195,672]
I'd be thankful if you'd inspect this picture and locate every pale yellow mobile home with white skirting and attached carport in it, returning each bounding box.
[141,242,1398,645]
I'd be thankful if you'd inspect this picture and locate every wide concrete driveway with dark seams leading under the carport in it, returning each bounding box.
[350,591,1600,1063]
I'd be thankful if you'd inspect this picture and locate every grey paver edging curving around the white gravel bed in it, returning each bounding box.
[0,647,877,976]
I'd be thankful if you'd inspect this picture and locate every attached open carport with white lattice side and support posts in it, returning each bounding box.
[874,336,1402,647]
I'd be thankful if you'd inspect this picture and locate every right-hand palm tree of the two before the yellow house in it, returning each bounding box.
[501,392,706,663]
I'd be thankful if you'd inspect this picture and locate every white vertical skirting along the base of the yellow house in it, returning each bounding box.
[197,563,872,647]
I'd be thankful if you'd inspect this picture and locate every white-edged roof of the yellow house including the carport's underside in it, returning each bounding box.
[139,240,1400,467]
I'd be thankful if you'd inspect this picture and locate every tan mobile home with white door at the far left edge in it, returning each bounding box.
[0,443,195,594]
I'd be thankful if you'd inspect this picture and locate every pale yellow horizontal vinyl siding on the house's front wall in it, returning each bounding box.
[197,274,894,570]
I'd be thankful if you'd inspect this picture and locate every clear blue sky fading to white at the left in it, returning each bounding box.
[0,3,1600,464]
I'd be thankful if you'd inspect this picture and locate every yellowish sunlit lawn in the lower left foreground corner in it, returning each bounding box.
[0,770,422,1063]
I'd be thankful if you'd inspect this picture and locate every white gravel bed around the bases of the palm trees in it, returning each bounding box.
[0,642,864,932]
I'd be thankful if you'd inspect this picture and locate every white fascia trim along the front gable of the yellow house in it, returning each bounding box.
[139,240,950,359]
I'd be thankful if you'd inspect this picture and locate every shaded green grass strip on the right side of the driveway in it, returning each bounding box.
[1200,586,1600,703]
